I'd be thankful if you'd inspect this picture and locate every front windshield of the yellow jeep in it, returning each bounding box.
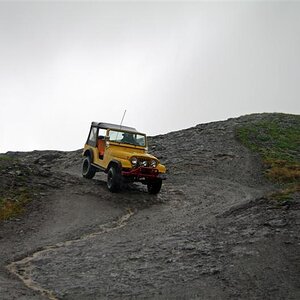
[108,130,146,147]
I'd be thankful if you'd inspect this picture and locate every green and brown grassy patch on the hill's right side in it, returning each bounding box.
[236,114,300,200]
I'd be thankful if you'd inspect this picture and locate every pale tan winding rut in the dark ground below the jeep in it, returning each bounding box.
[6,208,134,300]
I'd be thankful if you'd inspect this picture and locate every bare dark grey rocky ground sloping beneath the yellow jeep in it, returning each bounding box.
[0,115,300,299]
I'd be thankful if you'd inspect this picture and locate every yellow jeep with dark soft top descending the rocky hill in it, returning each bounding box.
[82,122,166,194]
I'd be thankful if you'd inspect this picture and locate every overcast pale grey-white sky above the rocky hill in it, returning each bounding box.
[0,1,300,152]
